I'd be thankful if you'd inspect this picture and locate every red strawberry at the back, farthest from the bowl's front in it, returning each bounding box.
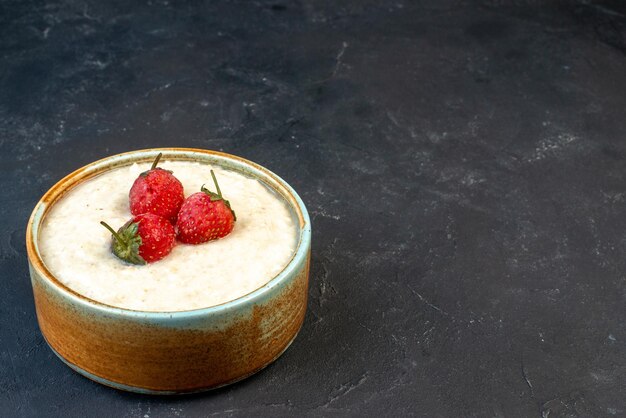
[129,153,185,223]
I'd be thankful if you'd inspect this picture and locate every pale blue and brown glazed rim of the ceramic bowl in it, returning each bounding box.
[26,147,311,322]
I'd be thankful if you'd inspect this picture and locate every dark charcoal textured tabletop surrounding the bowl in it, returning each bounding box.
[0,0,626,418]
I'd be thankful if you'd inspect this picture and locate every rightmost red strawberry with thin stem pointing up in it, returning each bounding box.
[176,170,237,244]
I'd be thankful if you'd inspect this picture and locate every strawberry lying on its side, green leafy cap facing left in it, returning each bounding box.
[100,213,176,264]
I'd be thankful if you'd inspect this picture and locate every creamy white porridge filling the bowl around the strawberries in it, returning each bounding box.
[39,160,297,311]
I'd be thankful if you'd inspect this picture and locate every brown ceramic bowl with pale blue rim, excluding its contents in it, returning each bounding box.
[26,148,311,394]
